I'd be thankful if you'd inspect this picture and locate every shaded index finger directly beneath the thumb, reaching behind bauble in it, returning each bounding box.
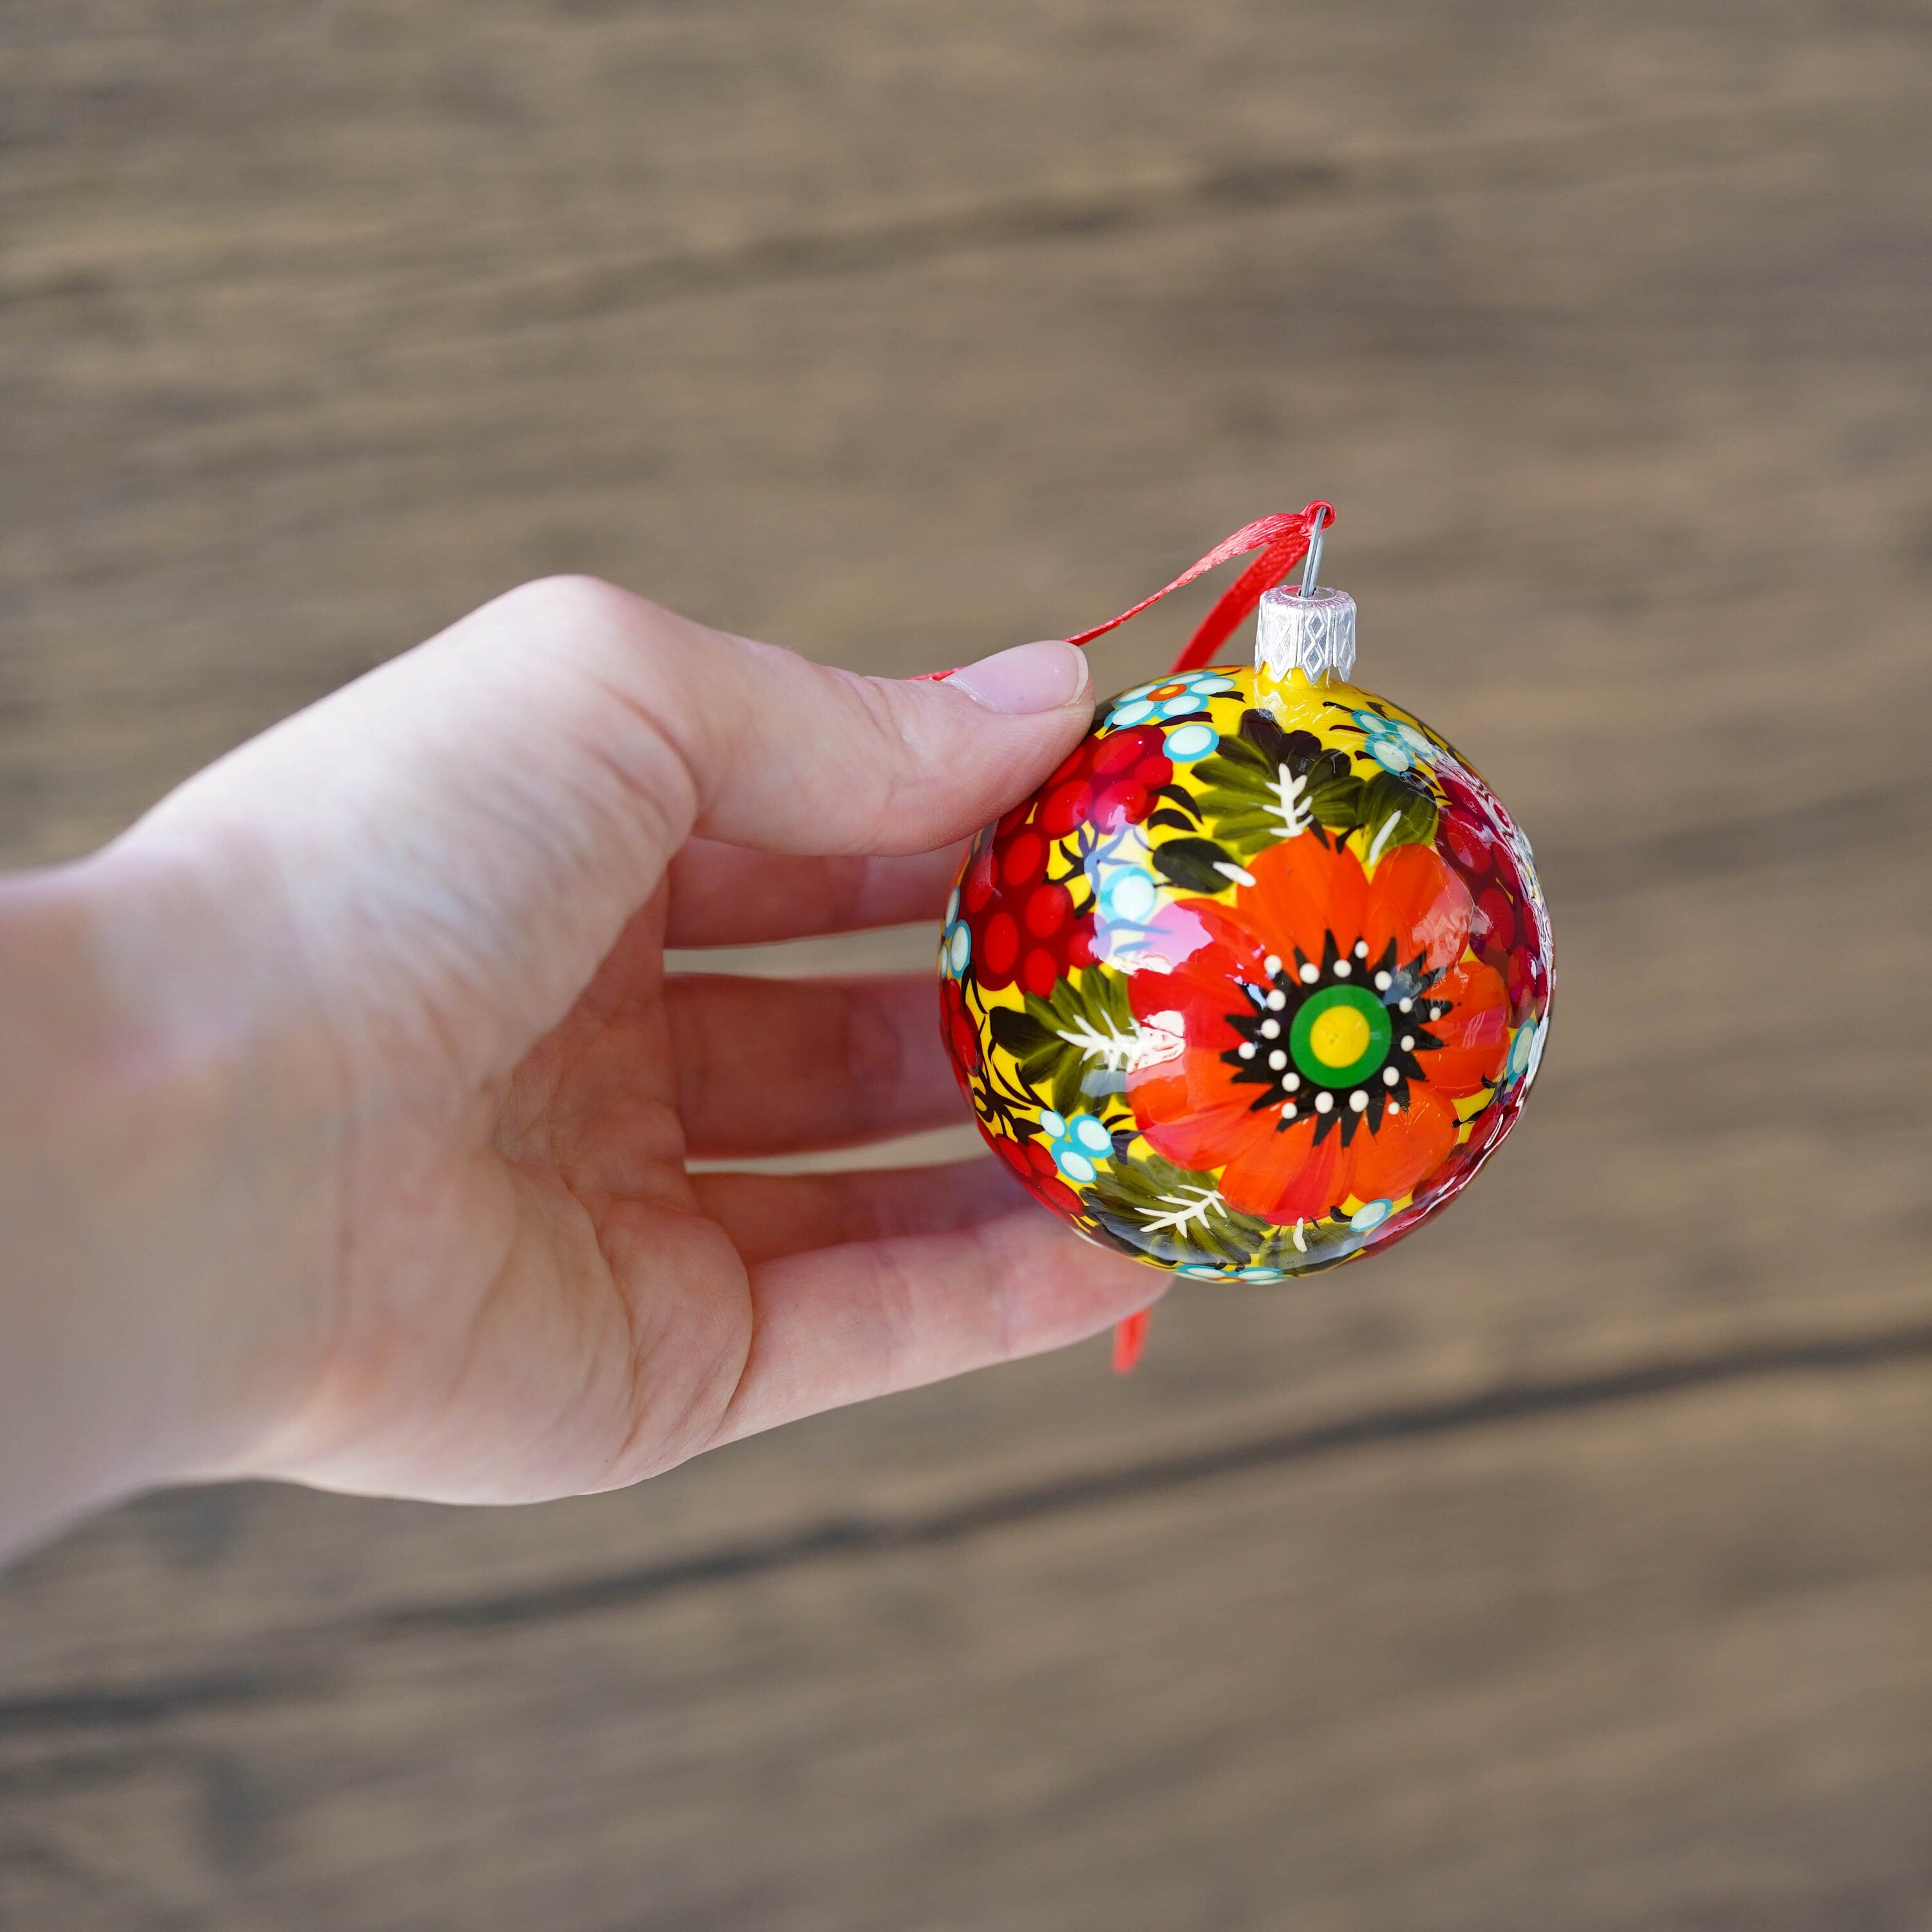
[665,838,962,947]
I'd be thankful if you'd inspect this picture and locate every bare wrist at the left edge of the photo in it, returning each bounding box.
[0,848,338,1544]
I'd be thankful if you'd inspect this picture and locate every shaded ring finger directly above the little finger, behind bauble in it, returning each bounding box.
[692,1155,1030,1265]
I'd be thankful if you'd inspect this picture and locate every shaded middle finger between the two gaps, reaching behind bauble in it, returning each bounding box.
[665,974,966,1159]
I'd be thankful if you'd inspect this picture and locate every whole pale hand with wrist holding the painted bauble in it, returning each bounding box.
[0,580,1163,1553]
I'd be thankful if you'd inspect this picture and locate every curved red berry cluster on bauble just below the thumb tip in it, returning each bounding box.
[960,724,1175,999]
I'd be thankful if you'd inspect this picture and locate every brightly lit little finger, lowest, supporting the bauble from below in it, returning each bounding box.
[717,1204,1171,1441]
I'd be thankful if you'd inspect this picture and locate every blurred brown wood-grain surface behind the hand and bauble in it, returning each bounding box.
[0,0,1932,1932]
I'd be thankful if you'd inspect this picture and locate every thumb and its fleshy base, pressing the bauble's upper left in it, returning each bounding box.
[113,578,1092,1059]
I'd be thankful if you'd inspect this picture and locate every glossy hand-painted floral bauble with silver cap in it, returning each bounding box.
[941,589,1549,1281]
